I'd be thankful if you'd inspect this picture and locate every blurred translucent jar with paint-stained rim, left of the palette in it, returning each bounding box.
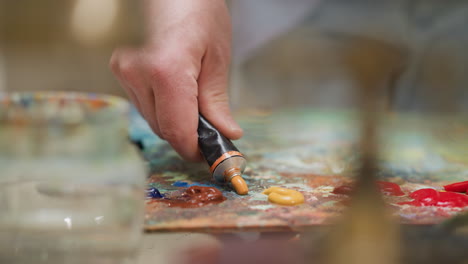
[0,93,146,264]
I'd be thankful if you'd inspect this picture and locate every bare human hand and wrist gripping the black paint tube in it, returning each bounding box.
[110,0,242,161]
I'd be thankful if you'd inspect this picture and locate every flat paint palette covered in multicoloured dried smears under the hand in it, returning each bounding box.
[130,109,468,232]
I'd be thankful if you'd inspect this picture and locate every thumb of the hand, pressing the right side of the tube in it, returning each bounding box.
[198,61,243,139]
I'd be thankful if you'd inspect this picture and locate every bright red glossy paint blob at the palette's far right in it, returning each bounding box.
[399,189,468,207]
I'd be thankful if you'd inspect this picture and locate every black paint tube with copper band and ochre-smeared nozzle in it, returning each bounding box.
[198,115,248,194]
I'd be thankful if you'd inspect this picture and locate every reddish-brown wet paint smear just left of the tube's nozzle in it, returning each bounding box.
[154,186,226,208]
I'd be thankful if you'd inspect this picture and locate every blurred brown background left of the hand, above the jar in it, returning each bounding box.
[0,0,144,96]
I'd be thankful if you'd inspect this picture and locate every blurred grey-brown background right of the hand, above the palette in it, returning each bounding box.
[232,0,468,111]
